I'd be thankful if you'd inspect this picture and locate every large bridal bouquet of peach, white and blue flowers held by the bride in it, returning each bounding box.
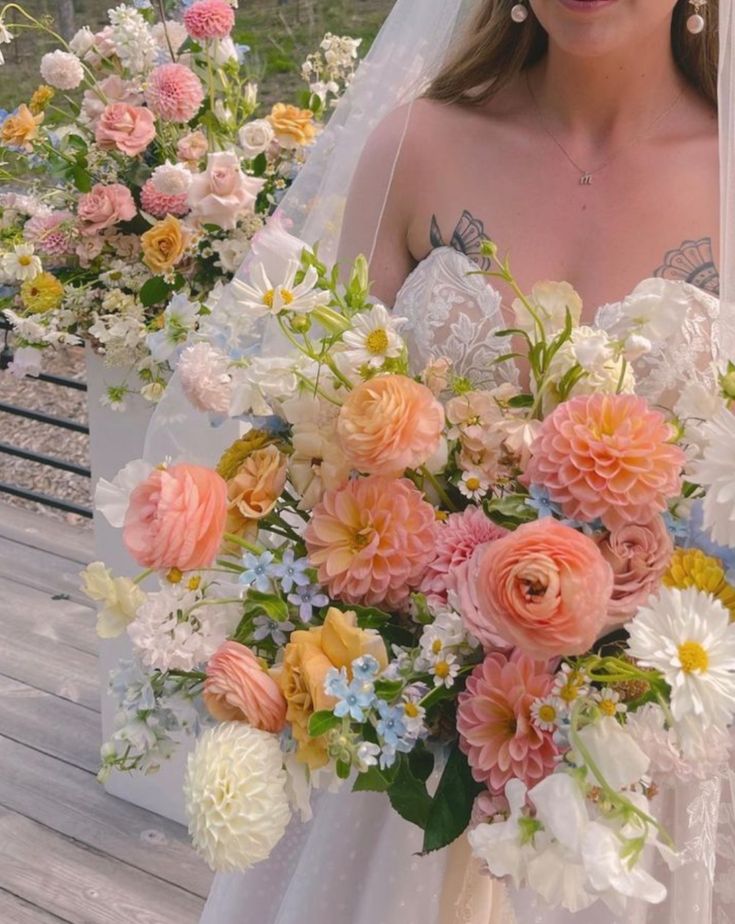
[85,224,735,913]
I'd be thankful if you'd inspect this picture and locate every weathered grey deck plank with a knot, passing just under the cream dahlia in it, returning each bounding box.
[0,738,212,900]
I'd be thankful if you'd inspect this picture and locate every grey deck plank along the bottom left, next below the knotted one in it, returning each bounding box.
[0,810,204,924]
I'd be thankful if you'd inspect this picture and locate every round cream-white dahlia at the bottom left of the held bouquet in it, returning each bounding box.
[184,722,291,872]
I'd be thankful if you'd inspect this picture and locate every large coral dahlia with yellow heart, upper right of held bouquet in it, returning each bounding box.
[526,394,685,529]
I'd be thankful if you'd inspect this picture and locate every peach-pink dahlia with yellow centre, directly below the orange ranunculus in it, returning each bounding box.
[304,475,436,607]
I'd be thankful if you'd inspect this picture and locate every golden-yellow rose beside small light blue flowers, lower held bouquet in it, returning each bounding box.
[278,607,388,770]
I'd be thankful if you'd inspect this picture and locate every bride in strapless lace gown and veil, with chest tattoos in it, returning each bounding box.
[194,0,735,924]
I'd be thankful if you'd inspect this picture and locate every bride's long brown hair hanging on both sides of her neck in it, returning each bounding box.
[426,0,719,108]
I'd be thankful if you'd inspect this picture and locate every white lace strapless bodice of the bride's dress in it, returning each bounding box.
[394,247,720,404]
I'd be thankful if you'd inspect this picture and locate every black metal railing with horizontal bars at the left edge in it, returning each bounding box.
[0,312,92,518]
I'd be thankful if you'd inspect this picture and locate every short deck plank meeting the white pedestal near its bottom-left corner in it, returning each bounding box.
[0,677,102,773]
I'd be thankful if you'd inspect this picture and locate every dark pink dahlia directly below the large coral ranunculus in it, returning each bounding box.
[457,651,558,795]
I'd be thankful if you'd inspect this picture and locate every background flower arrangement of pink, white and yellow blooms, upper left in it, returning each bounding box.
[0,0,359,410]
